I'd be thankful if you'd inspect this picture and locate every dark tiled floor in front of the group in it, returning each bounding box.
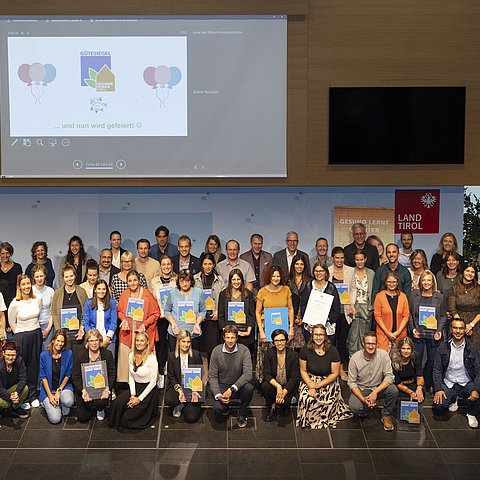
[0,386,480,480]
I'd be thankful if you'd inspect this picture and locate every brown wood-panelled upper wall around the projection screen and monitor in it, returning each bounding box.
[0,0,480,186]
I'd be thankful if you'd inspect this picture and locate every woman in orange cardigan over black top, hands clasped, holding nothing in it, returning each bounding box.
[373,271,410,352]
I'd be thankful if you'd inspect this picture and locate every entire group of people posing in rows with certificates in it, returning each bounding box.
[0,224,480,430]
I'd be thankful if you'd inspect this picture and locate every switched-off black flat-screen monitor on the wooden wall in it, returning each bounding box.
[329,86,466,165]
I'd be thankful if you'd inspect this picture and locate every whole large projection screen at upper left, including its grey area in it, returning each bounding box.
[0,15,287,178]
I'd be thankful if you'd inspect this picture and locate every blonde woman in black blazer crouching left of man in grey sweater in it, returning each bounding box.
[165,330,202,423]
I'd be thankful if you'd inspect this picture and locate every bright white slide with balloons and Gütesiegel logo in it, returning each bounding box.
[8,36,188,137]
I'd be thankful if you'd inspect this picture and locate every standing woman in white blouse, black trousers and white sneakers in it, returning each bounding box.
[8,274,43,410]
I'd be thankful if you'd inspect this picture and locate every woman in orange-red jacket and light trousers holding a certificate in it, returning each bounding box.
[117,270,160,382]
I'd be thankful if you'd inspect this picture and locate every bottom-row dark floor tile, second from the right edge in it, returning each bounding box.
[370,449,448,478]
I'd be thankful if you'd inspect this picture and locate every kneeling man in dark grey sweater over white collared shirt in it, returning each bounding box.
[209,325,253,428]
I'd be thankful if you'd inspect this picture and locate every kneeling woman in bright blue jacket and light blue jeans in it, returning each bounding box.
[40,329,73,424]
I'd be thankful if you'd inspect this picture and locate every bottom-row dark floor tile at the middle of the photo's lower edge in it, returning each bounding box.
[228,449,300,478]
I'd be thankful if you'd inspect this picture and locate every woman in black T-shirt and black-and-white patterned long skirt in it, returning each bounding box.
[297,325,353,428]
